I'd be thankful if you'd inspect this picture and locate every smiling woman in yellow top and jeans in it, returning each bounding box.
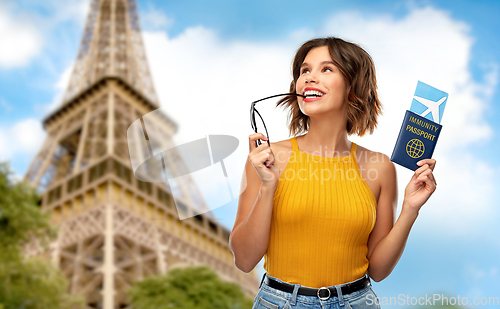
[229,37,436,308]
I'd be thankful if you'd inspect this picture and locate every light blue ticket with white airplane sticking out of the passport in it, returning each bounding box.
[410,81,448,123]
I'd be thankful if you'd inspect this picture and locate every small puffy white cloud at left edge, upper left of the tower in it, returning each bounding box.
[0,3,42,68]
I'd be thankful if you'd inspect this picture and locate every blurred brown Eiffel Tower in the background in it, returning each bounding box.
[26,0,259,309]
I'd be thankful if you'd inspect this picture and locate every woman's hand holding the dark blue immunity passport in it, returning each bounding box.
[403,159,436,213]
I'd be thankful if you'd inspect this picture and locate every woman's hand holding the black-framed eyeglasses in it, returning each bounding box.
[248,133,279,188]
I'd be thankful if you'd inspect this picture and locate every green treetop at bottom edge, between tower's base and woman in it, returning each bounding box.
[129,266,253,309]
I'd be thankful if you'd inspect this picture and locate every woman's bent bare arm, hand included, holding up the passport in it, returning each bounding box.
[367,159,436,282]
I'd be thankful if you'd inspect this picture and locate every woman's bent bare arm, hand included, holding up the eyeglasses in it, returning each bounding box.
[229,133,279,272]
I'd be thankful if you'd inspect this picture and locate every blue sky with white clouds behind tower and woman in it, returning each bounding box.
[0,0,500,308]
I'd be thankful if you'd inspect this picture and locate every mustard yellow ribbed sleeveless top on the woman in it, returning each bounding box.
[264,138,377,288]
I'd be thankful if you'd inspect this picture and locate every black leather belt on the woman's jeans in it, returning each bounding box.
[264,275,371,300]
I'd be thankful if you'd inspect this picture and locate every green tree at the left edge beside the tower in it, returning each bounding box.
[0,163,83,309]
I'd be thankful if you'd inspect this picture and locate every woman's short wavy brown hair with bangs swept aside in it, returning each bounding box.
[276,37,382,136]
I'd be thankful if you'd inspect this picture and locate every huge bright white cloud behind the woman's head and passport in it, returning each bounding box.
[144,7,498,233]
